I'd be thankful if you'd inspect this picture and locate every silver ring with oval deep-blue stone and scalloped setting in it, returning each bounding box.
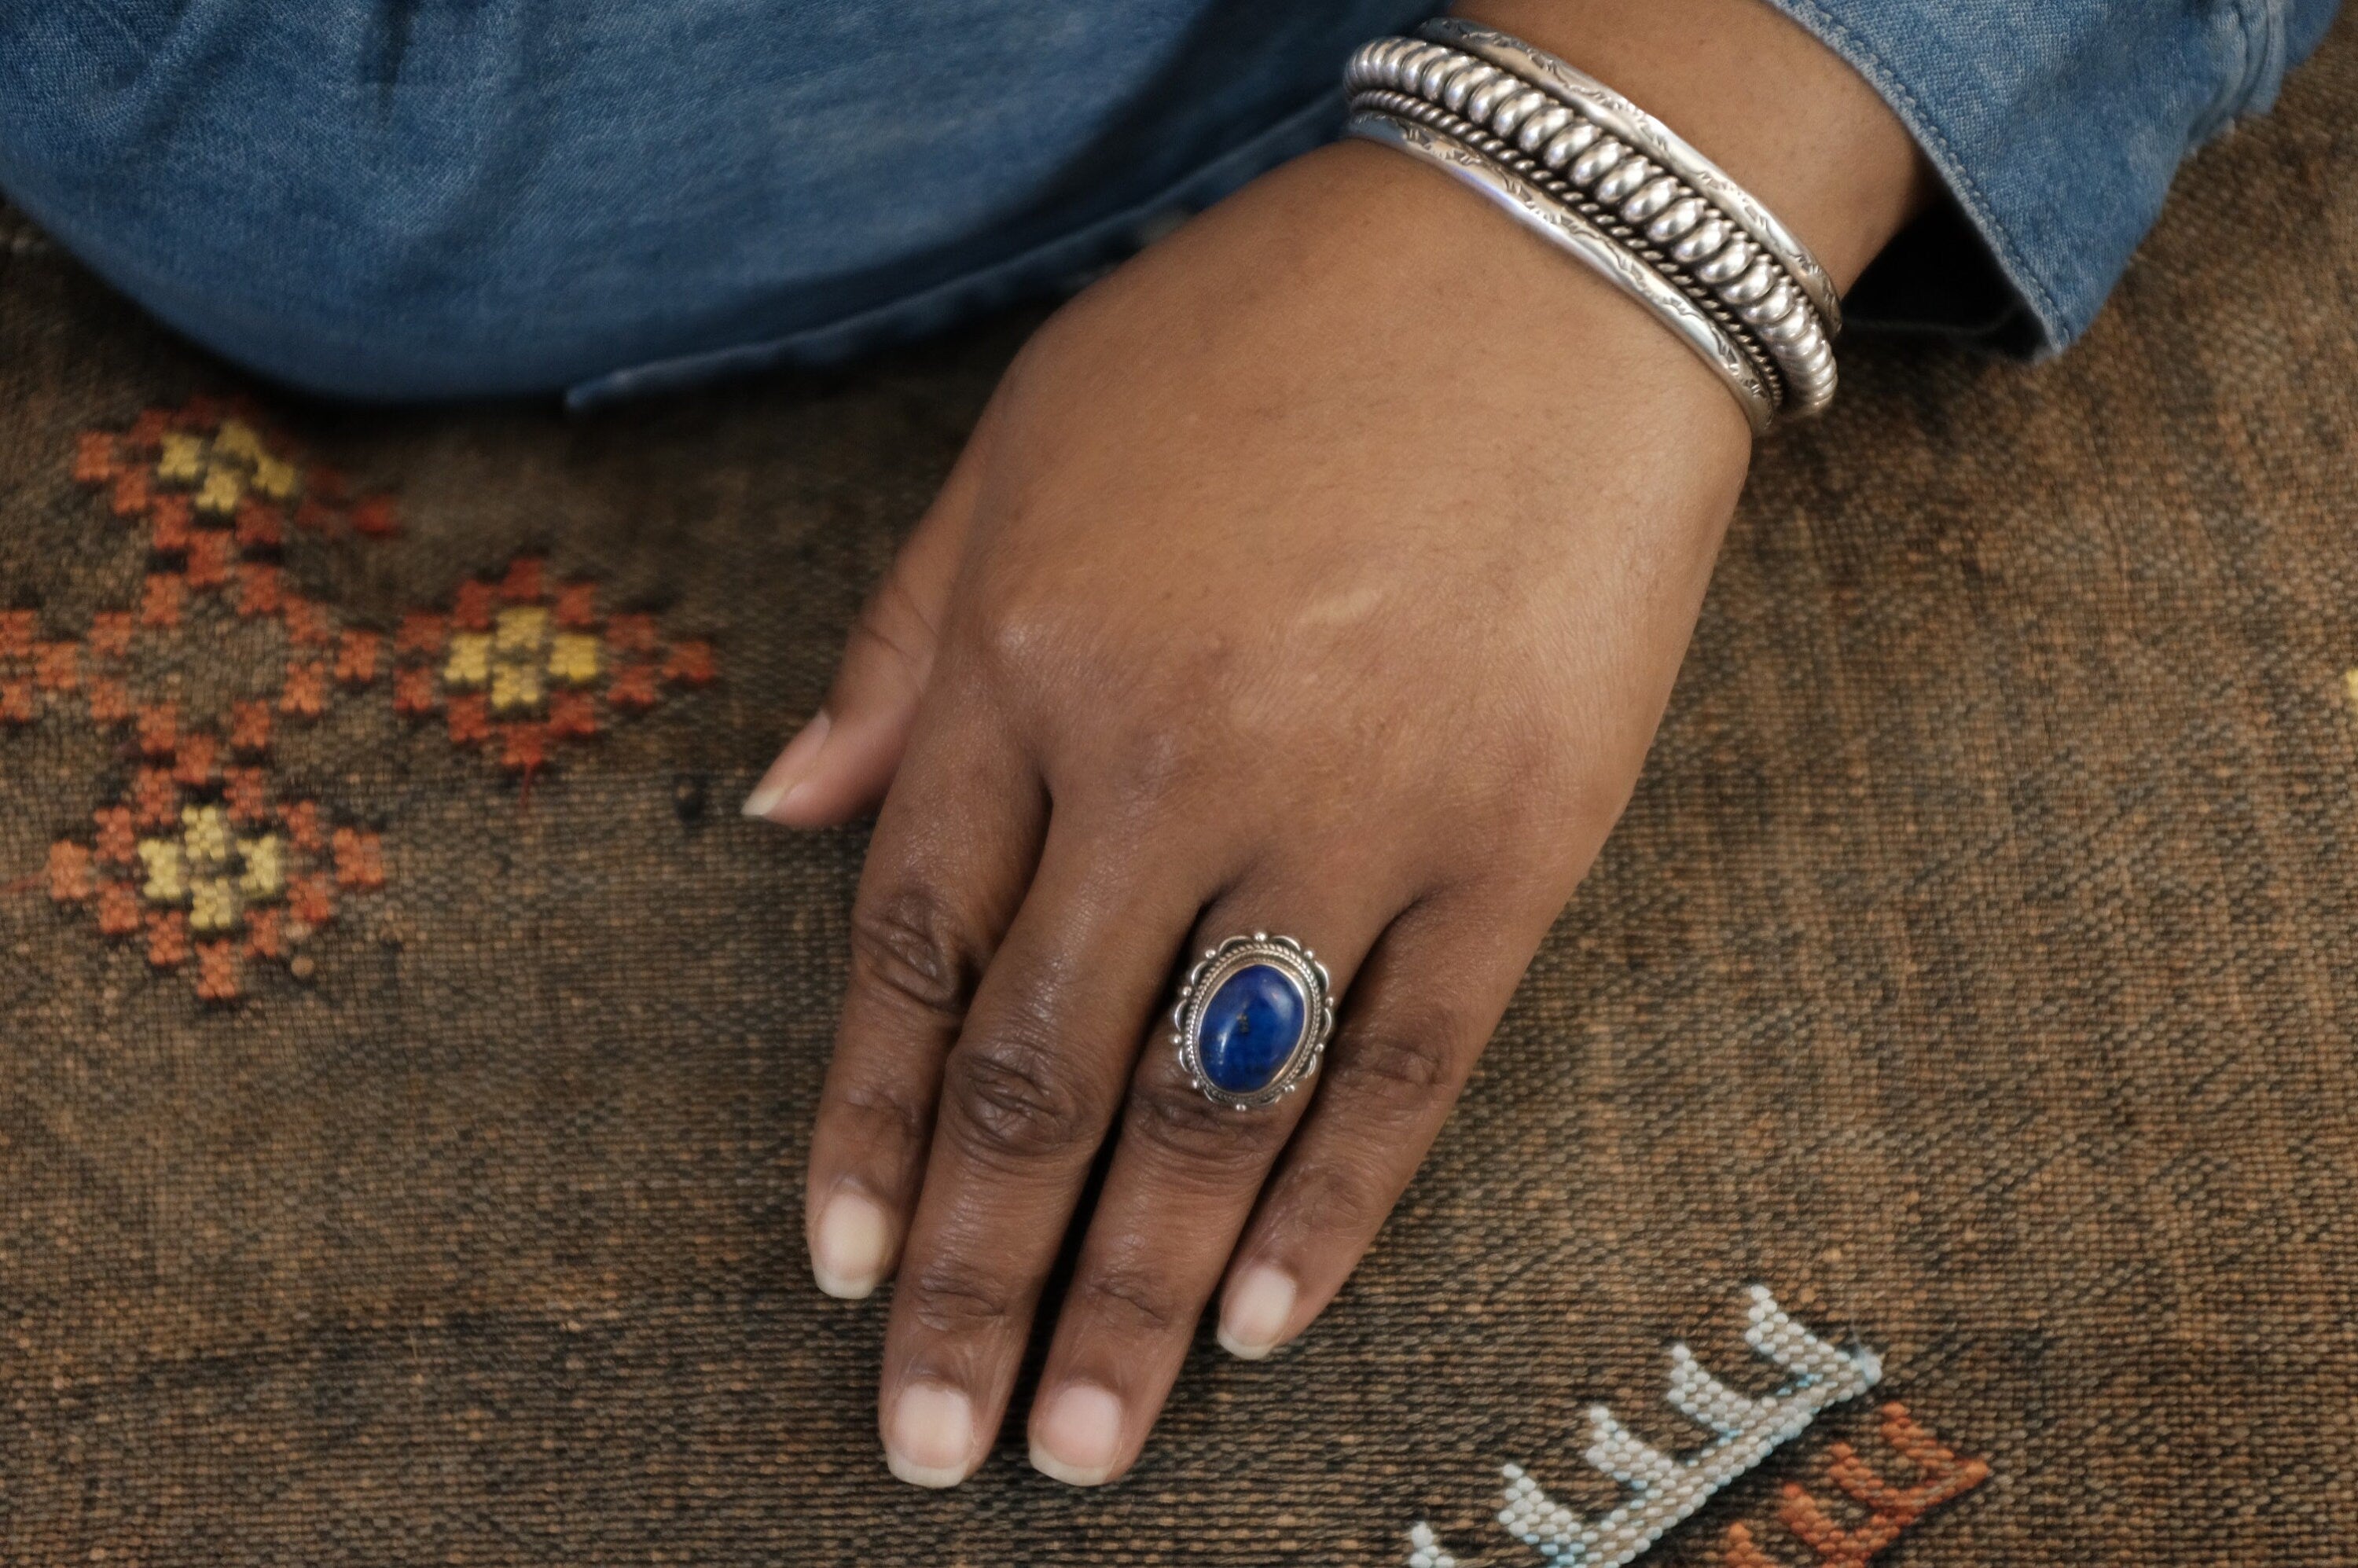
[1172,931,1335,1111]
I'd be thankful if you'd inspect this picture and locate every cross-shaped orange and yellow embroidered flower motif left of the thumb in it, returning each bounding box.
[0,398,717,1004]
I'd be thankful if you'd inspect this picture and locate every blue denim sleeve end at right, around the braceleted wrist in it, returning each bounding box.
[1771,0,2339,354]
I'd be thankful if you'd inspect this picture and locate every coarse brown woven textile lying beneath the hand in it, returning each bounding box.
[0,24,2358,1566]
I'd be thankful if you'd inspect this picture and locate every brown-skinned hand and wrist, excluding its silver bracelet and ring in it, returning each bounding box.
[747,0,1929,1485]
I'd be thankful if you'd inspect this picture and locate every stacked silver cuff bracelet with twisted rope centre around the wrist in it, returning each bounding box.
[1344,19,1842,434]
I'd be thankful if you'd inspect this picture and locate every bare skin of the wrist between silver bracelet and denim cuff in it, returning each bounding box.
[1457,0,1938,288]
